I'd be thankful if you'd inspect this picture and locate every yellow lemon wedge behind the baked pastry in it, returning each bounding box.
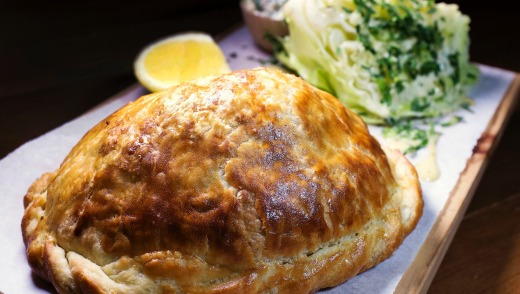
[134,32,230,92]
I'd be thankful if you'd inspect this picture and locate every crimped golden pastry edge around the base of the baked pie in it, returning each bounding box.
[22,149,423,293]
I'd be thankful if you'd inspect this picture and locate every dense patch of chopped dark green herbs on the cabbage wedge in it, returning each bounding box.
[356,0,443,112]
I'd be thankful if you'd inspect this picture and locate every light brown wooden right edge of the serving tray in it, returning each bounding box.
[395,75,520,293]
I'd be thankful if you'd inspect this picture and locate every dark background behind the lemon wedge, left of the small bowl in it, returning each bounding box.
[0,0,241,158]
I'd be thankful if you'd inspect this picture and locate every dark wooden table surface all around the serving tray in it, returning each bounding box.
[0,0,520,293]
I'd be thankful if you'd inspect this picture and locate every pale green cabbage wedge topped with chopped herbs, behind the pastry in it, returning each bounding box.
[275,0,478,125]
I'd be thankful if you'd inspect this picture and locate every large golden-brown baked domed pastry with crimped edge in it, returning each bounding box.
[22,68,423,293]
